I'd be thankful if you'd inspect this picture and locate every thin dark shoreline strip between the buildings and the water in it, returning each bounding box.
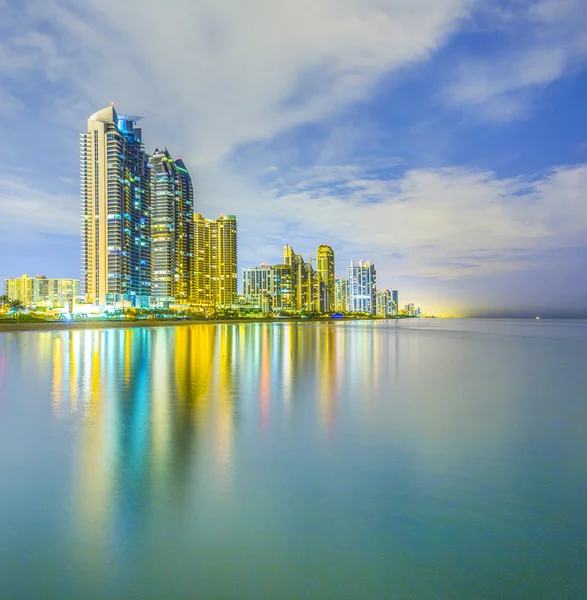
[0,317,396,334]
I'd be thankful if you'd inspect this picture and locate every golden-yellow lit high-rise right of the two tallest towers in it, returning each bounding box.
[191,214,238,309]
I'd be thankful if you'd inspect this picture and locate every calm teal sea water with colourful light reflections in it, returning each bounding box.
[0,320,587,600]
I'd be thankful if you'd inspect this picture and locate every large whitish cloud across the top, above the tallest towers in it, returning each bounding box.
[0,0,471,159]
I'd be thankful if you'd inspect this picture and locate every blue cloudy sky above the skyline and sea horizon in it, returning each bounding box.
[0,0,587,316]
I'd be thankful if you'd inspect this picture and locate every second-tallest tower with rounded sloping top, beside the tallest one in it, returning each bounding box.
[151,149,194,304]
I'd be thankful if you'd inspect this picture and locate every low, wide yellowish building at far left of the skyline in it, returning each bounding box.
[5,275,79,308]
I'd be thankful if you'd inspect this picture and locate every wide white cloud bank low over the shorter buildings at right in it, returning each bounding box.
[237,165,587,278]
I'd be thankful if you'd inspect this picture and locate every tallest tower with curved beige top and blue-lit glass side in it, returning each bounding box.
[80,106,151,307]
